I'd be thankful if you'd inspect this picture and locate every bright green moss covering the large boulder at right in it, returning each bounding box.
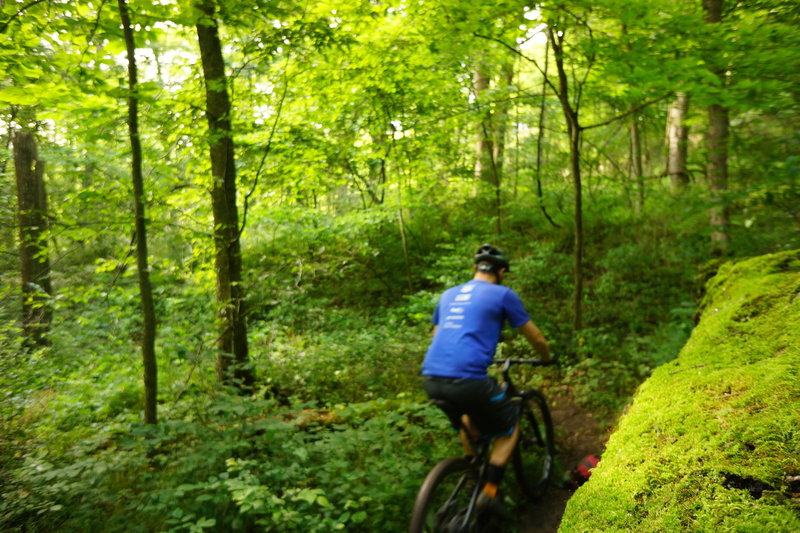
[559,251,800,533]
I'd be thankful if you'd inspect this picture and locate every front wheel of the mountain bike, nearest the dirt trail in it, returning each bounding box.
[513,390,555,499]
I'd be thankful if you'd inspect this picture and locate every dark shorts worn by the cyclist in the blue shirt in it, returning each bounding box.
[423,376,519,437]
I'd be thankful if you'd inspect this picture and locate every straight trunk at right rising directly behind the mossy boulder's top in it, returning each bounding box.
[703,0,730,255]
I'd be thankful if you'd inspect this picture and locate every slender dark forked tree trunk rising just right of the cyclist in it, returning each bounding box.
[547,27,584,331]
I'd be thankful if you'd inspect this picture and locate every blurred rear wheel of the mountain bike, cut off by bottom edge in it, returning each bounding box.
[408,457,478,533]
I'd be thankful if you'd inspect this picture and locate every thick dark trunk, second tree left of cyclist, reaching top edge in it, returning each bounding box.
[197,0,254,390]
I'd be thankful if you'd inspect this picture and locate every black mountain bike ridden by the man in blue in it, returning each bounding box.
[409,358,556,533]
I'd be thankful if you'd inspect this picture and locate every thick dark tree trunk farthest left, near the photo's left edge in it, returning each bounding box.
[13,131,53,349]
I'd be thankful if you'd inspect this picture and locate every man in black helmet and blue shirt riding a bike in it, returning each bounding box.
[422,244,550,505]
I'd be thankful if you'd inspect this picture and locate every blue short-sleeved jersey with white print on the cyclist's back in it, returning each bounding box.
[422,280,530,379]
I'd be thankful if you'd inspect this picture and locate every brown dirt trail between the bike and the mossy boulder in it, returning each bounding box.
[521,386,611,533]
